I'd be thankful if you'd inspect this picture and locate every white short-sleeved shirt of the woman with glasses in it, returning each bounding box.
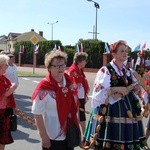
[32,78,66,140]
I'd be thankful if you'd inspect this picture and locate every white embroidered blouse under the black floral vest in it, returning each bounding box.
[91,61,136,108]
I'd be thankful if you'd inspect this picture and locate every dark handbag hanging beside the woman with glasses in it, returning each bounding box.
[66,119,81,148]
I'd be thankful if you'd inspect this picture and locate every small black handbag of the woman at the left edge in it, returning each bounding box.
[10,114,17,131]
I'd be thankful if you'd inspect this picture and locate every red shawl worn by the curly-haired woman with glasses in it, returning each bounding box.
[32,73,78,129]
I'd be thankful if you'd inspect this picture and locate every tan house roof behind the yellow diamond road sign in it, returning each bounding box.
[15,31,47,42]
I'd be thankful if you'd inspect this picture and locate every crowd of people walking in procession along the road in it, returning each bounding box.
[0,40,150,150]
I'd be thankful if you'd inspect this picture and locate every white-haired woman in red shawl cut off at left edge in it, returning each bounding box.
[0,54,17,150]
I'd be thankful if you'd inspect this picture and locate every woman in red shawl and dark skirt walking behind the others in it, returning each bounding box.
[68,52,89,137]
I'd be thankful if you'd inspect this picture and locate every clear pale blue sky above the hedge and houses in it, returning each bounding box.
[0,0,150,48]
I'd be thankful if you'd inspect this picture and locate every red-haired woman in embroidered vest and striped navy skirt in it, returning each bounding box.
[82,41,146,150]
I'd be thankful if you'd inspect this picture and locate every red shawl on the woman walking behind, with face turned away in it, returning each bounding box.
[68,63,90,95]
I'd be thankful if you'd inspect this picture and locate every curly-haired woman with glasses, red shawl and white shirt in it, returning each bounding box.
[32,50,80,150]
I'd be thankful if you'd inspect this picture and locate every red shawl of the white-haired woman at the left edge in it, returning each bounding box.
[0,75,16,108]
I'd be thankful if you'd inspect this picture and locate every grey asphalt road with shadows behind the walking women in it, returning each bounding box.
[6,68,150,150]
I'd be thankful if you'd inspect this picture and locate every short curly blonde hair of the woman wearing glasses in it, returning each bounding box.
[44,50,67,68]
